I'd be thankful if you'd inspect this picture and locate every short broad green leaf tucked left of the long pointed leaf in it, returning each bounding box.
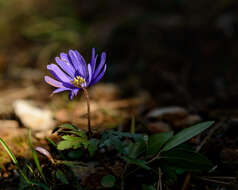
[147,132,173,155]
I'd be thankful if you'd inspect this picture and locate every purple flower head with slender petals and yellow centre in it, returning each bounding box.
[45,48,107,100]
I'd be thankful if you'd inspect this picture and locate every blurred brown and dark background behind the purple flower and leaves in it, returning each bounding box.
[0,0,238,187]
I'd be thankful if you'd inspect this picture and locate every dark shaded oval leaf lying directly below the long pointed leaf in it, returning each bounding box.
[159,149,212,172]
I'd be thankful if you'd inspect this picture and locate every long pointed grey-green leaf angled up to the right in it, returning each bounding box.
[161,121,214,152]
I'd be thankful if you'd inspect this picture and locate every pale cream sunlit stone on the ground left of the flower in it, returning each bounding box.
[13,100,55,131]
